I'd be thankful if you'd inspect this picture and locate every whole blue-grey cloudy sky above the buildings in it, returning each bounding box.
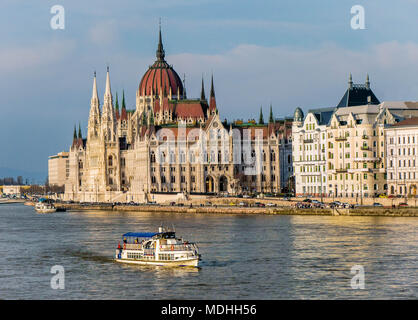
[0,0,418,177]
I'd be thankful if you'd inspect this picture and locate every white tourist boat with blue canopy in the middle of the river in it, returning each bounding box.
[116,227,200,267]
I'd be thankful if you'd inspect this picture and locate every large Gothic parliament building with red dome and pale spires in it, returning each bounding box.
[59,30,293,202]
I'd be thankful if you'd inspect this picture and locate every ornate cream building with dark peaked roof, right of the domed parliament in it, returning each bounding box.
[293,75,418,198]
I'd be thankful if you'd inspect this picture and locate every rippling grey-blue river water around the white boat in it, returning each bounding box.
[0,205,418,299]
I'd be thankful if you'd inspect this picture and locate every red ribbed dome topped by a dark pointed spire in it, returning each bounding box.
[139,29,183,96]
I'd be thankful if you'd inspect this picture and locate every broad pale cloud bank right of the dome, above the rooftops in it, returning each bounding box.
[168,42,418,117]
